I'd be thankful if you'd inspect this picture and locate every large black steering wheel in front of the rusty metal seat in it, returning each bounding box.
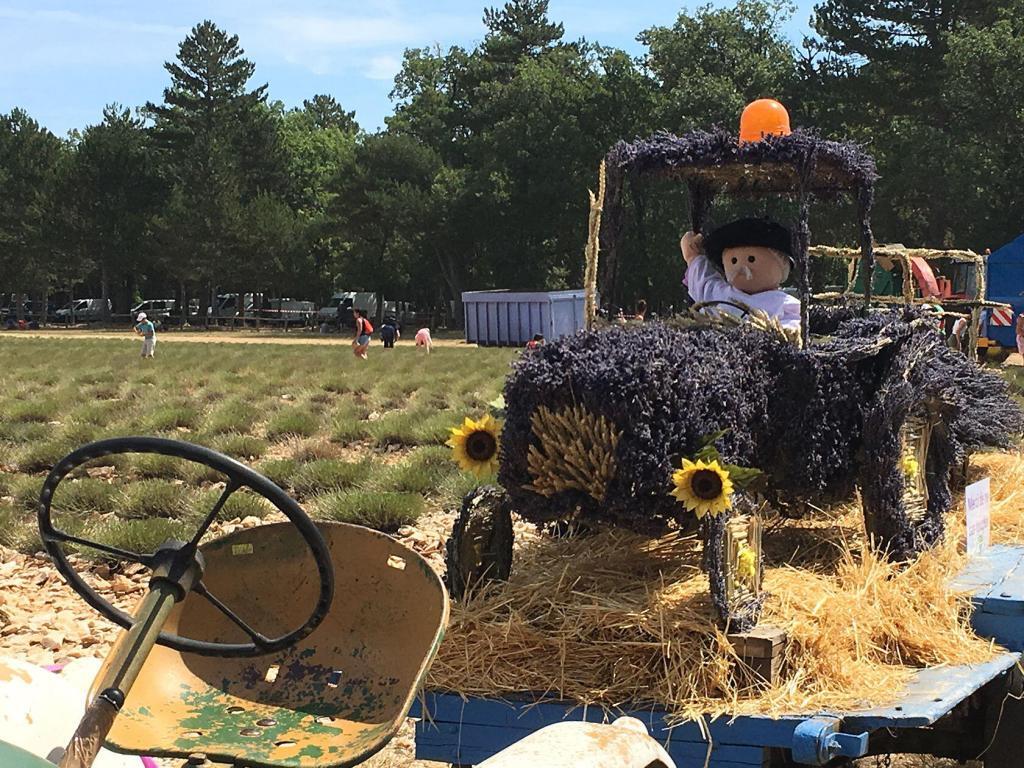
[39,437,334,656]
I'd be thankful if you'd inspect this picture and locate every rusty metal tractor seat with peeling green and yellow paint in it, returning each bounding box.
[93,523,447,768]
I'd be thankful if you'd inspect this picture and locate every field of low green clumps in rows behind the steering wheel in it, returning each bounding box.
[0,338,515,551]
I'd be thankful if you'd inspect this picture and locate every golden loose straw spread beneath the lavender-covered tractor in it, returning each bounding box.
[428,454,1024,719]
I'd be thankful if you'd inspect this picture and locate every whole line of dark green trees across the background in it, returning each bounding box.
[0,0,1024,321]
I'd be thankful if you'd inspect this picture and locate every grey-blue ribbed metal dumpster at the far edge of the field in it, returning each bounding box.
[462,288,586,346]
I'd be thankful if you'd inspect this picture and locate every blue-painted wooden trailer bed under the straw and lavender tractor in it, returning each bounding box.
[412,547,1024,768]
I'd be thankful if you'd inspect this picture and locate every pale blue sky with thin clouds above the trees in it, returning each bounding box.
[0,0,814,135]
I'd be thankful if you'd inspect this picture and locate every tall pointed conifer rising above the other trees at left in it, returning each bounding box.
[146,22,287,315]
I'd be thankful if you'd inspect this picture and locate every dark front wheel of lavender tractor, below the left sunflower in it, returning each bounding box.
[444,485,513,600]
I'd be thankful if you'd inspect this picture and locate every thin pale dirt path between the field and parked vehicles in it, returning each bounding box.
[0,329,477,349]
